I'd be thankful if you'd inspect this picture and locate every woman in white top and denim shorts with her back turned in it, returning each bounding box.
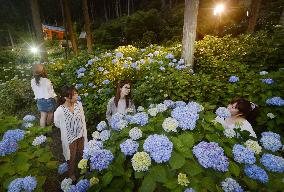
[31,64,56,127]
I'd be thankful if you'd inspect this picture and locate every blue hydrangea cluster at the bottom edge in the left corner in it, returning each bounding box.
[8,176,37,192]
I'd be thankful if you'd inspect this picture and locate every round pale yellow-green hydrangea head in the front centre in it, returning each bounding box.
[131,152,151,172]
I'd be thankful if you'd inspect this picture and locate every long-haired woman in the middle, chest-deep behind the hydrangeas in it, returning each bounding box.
[106,80,135,121]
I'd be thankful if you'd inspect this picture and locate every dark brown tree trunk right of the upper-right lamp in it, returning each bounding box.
[247,0,261,33]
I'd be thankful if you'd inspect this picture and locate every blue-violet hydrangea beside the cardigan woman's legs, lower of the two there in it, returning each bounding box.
[90,149,113,171]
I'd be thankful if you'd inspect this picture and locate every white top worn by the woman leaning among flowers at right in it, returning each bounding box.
[215,116,256,138]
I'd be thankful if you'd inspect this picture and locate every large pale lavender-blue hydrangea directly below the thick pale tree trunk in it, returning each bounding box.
[171,107,199,130]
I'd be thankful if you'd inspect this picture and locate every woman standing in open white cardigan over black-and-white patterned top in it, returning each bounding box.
[54,86,88,181]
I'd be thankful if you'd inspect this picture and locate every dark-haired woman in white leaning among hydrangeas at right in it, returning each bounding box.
[215,98,259,138]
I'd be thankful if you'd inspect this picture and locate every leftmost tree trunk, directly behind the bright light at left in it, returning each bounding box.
[30,0,47,61]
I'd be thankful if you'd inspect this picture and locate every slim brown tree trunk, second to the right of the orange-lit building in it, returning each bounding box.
[83,0,93,53]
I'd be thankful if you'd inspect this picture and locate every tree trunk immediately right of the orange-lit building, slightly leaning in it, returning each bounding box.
[63,0,78,55]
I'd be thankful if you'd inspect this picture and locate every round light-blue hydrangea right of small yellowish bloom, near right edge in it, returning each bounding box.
[260,131,282,152]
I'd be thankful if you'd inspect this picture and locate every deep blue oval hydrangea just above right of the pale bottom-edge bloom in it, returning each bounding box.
[244,165,268,183]
